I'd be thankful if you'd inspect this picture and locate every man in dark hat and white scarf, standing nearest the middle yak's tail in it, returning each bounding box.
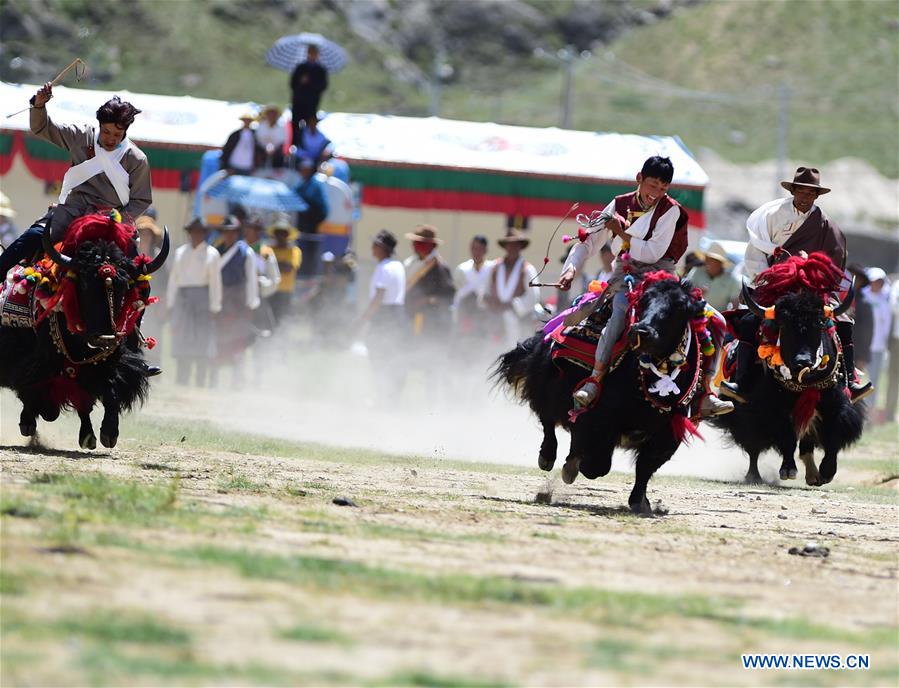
[487,229,540,347]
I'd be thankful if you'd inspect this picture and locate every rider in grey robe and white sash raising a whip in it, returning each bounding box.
[0,82,152,279]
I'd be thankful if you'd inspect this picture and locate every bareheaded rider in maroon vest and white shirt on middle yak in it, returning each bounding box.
[559,155,734,416]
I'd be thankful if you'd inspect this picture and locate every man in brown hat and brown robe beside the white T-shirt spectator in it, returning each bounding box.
[403,225,456,342]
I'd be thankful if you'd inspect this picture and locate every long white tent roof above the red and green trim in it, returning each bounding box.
[0,82,708,188]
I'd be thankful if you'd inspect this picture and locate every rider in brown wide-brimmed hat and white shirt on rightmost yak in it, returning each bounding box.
[721,167,873,402]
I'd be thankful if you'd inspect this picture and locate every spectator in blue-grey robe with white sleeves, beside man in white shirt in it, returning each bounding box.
[212,216,259,389]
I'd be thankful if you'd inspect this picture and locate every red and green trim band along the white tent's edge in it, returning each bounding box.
[0,130,705,227]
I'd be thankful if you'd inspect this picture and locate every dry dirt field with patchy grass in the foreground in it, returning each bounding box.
[0,384,899,686]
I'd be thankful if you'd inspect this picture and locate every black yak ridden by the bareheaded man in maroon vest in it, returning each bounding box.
[493,272,705,514]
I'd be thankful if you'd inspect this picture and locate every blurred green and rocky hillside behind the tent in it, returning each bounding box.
[0,0,899,177]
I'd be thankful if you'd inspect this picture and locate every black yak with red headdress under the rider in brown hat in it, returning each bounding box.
[711,253,865,485]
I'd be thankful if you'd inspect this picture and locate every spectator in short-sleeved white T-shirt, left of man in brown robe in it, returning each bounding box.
[359,229,407,401]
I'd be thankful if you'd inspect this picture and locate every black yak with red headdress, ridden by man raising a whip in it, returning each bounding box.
[0,214,169,449]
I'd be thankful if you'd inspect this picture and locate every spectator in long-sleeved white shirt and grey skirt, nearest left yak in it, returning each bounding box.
[166,218,222,387]
